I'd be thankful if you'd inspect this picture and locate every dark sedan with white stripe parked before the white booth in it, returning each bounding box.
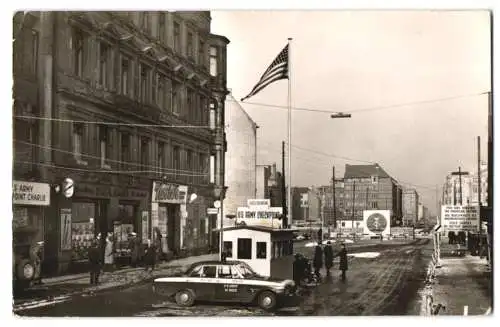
[153,260,295,311]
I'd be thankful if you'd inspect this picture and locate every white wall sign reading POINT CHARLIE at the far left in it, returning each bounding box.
[12,181,50,206]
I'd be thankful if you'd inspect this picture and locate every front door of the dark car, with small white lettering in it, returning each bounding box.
[215,264,244,302]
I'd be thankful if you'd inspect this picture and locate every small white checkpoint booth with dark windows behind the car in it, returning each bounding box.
[218,225,295,279]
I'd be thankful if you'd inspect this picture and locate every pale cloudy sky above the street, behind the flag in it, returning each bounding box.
[211,10,491,217]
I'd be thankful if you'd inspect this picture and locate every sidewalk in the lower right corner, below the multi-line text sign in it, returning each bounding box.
[432,255,493,315]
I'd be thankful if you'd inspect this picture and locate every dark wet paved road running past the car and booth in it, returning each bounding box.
[17,240,431,317]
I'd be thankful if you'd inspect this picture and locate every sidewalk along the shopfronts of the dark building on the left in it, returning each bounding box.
[15,253,218,303]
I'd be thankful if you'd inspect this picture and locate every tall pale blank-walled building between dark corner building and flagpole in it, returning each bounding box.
[224,95,258,219]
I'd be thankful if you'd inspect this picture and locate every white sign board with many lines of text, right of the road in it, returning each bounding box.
[441,205,479,233]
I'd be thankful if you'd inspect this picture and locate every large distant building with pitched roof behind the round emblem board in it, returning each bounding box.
[340,164,402,225]
